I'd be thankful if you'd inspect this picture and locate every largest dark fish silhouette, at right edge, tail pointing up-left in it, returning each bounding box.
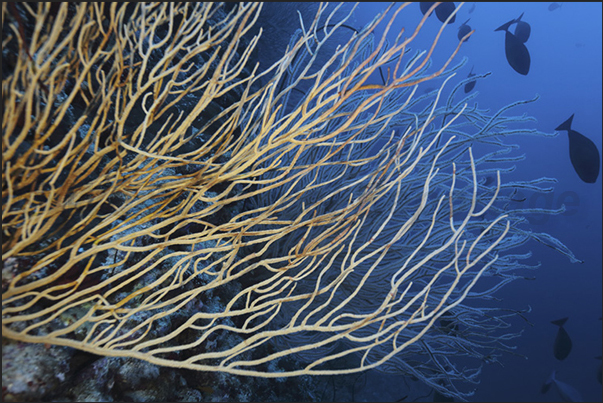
[555,115,601,183]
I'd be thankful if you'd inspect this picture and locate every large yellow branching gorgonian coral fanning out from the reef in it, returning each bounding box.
[2,3,580,400]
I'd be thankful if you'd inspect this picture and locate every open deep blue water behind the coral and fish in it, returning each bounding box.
[344,3,603,401]
